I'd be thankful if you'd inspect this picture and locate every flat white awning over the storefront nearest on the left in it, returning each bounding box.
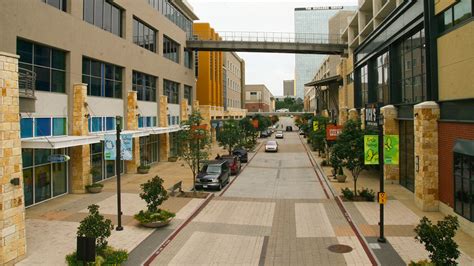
[21,136,100,149]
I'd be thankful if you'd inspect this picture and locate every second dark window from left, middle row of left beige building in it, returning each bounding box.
[82,57,122,98]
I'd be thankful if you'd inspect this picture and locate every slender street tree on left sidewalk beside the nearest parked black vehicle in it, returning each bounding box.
[177,111,211,188]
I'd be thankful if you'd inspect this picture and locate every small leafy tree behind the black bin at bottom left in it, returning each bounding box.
[77,204,114,252]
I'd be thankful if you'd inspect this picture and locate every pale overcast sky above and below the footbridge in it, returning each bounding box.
[187,0,357,96]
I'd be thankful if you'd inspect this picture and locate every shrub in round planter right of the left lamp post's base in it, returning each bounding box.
[134,176,175,228]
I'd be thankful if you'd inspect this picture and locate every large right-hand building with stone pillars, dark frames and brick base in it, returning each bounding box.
[339,0,474,235]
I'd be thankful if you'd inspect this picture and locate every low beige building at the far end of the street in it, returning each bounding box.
[245,84,275,112]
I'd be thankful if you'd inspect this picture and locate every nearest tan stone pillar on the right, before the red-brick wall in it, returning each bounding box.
[413,101,440,211]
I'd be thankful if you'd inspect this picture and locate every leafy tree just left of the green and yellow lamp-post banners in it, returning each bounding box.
[333,120,365,196]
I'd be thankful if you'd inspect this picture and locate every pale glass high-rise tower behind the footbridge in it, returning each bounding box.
[294,6,355,99]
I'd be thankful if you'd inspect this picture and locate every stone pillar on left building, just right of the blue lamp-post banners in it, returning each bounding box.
[125,91,140,174]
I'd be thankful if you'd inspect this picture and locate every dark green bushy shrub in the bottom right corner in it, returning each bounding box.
[415,215,460,265]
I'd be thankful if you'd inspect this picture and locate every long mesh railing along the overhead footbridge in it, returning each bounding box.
[188,31,346,44]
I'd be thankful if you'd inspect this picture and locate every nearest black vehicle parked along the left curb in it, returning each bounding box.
[195,160,230,190]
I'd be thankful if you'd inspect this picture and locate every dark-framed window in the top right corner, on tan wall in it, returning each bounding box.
[437,0,473,33]
